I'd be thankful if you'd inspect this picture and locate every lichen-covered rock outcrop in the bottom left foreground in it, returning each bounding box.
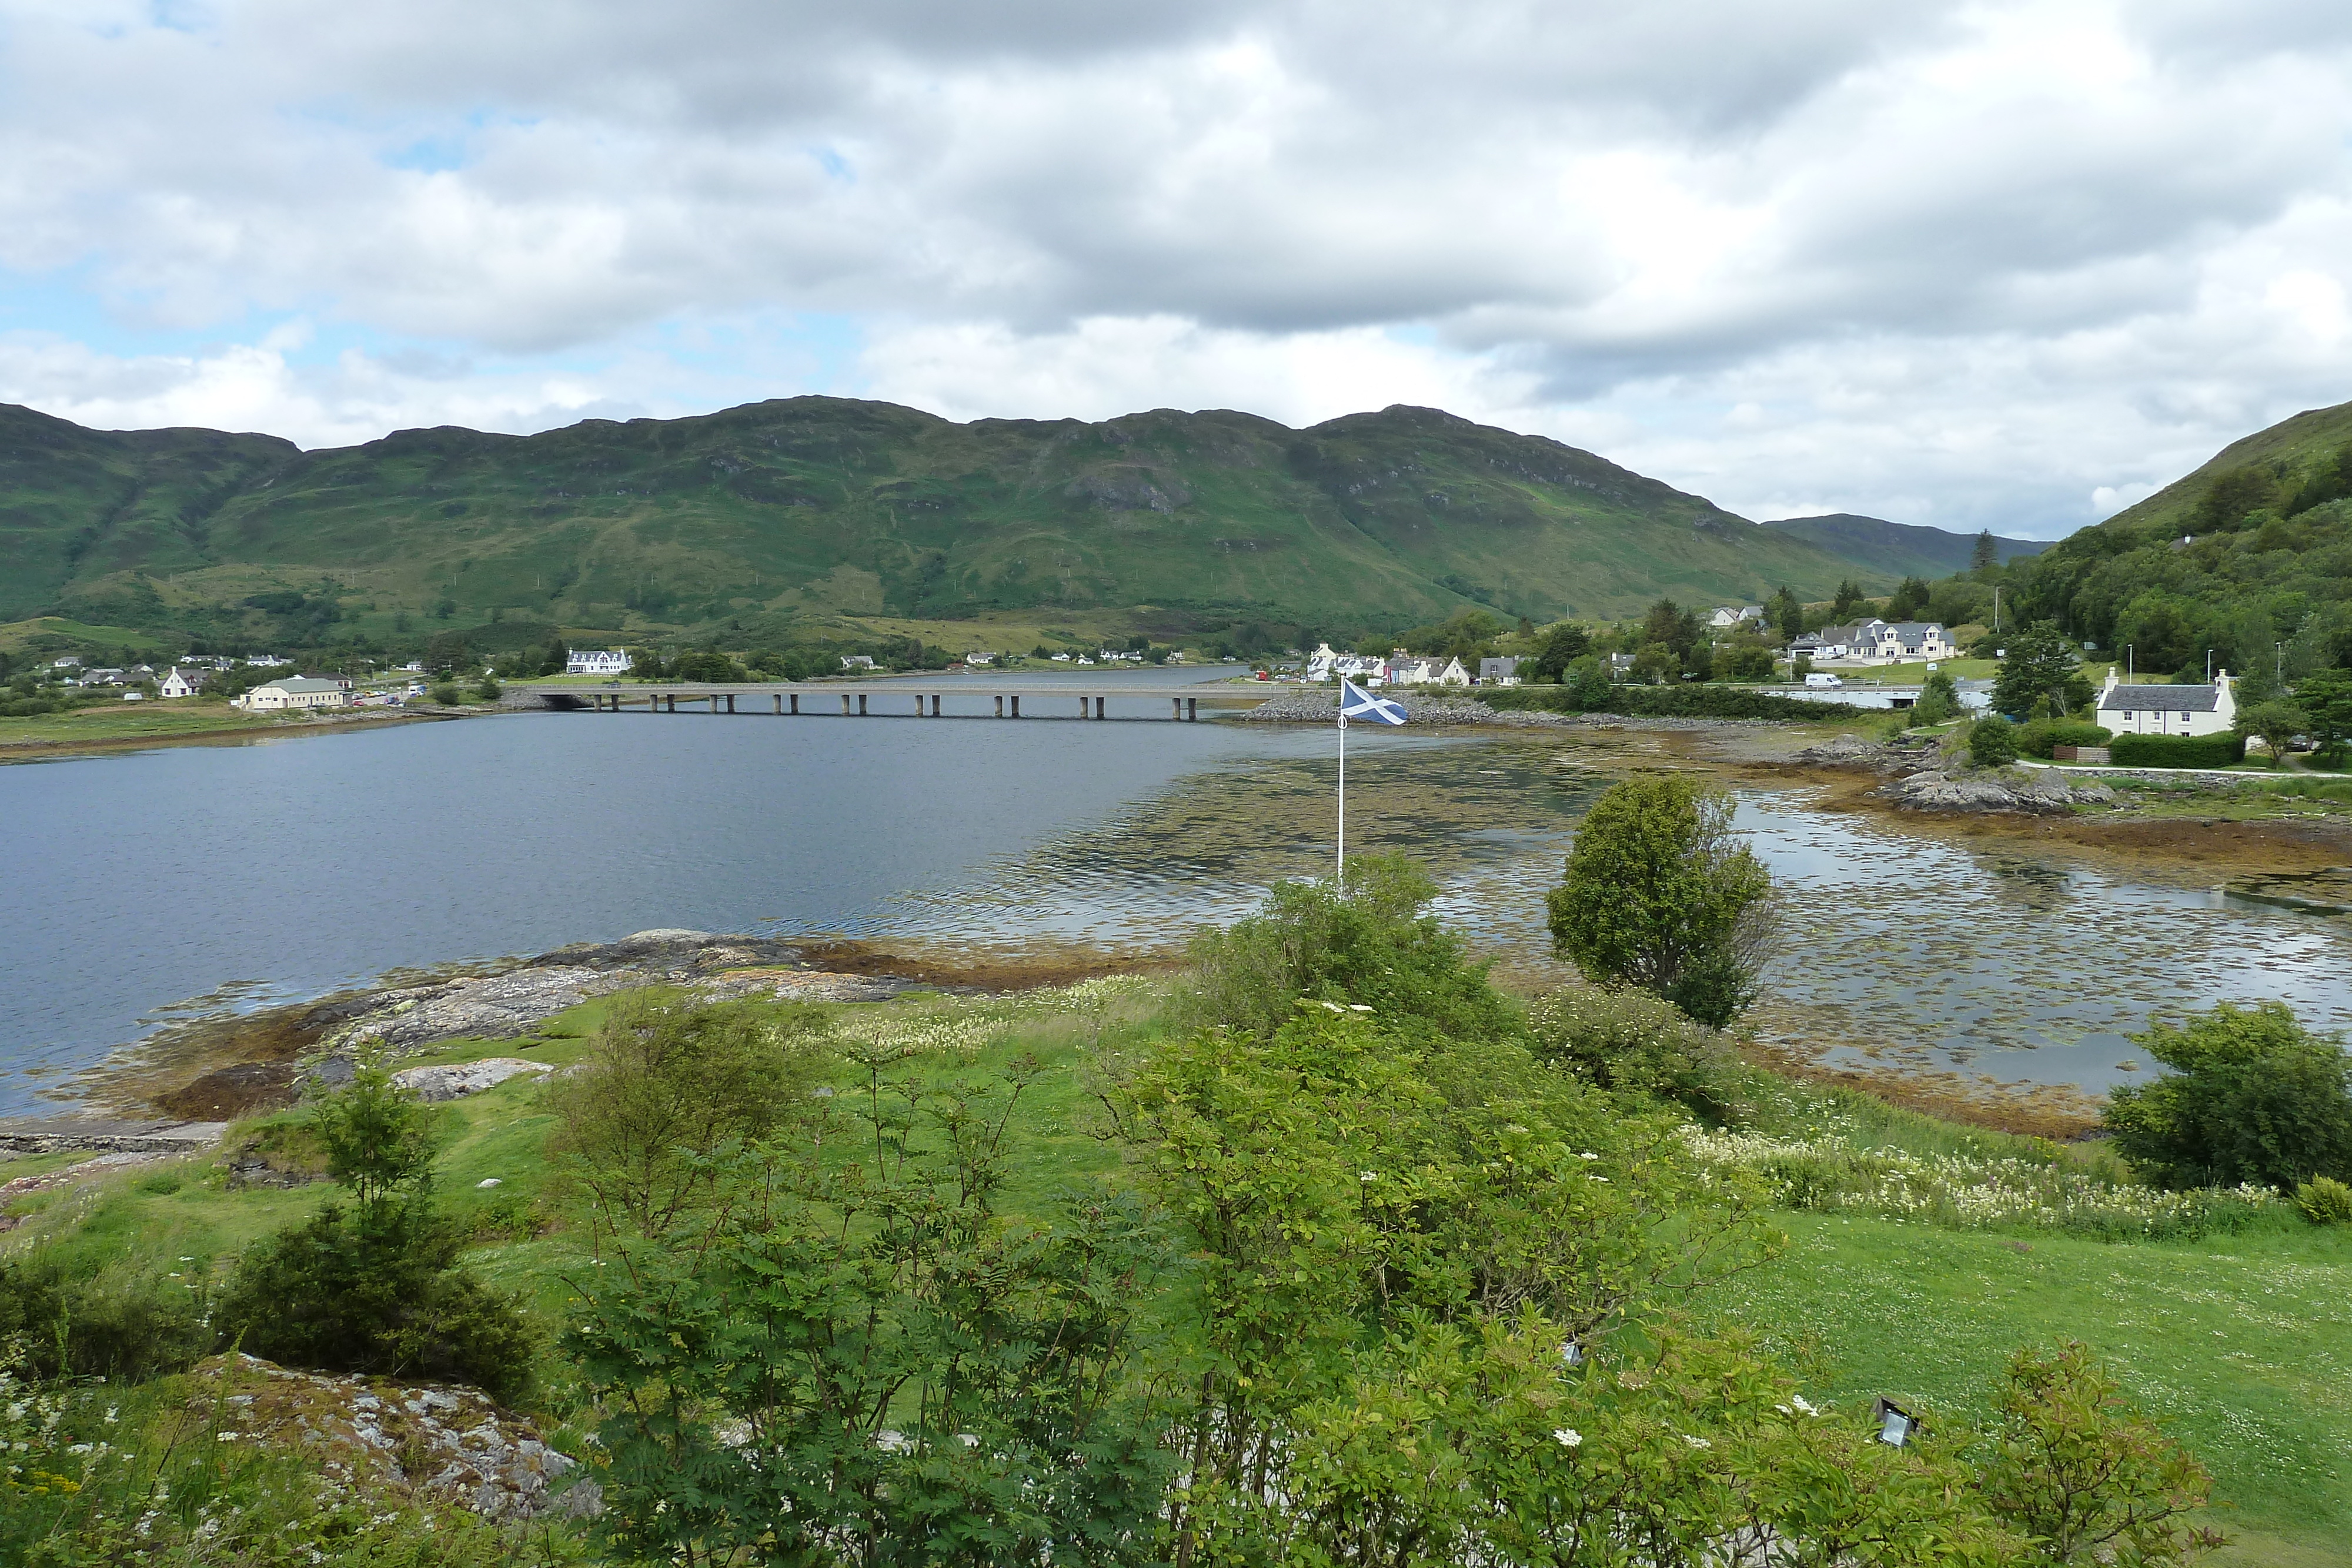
[188,1354,602,1523]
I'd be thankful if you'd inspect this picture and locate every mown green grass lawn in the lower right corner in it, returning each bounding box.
[1708,1213,2352,1563]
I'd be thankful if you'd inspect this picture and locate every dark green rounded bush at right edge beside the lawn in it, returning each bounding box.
[2105,1001,2352,1192]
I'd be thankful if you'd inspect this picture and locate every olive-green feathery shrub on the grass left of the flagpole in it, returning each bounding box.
[548,992,833,1236]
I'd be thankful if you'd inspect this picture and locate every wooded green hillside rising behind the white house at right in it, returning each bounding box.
[1957,404,2352,682]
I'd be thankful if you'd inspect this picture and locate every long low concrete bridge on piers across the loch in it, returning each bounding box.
[522,680,1275,724]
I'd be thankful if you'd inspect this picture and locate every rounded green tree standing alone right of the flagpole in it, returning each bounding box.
[1545,774,1771,1027]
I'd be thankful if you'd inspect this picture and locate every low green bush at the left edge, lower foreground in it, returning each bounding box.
[0,1241,212,1382]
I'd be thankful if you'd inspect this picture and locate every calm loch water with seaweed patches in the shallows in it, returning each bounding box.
[0,673,2352,1114]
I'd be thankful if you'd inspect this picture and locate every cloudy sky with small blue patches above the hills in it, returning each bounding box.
[0,0,2352,536]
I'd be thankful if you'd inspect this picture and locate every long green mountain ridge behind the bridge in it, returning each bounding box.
[0,397,1896,630]
